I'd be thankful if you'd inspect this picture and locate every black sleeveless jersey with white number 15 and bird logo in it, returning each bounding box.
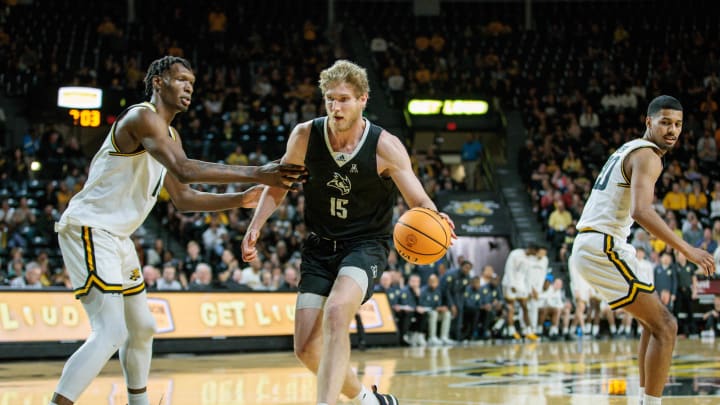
[303,117,397,240]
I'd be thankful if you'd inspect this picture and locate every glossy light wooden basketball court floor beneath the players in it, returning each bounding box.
[0,340,720,405]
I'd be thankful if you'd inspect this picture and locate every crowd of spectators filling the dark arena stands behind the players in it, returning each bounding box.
[0,0,720,344]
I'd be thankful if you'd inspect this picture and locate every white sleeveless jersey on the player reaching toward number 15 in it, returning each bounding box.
[59,102,176,237]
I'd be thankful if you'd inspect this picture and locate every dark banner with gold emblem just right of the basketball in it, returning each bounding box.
[435,192,512,236]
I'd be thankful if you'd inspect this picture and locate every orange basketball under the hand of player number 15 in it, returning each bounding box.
[393,207,452,264]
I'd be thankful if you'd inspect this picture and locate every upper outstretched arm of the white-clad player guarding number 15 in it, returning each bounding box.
[121,108,305,188]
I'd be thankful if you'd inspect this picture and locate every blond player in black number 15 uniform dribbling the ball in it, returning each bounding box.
[242,60,455,405]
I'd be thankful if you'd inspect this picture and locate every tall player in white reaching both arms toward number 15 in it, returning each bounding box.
[51,56,305,405]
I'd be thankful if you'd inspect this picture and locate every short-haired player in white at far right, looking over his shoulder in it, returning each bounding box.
[570,96,715,405]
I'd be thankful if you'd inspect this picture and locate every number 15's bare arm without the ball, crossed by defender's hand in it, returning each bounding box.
[242,121,312,262]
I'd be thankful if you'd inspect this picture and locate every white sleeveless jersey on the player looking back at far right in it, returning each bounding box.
[577,139,659,240]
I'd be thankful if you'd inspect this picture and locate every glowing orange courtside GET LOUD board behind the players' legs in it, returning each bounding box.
[0,290,396,342]
